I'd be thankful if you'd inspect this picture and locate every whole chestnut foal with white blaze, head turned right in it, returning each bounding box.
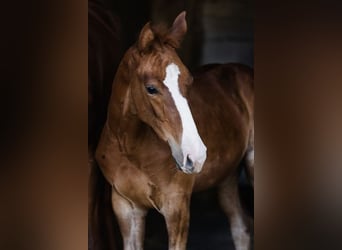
[95,11,254,250]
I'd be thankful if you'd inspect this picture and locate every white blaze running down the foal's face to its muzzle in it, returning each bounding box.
[164,63,207,172]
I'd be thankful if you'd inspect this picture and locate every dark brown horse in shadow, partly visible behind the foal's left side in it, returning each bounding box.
[88,0,123,250]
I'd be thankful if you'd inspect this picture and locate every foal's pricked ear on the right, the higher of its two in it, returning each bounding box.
[168,11,187,48]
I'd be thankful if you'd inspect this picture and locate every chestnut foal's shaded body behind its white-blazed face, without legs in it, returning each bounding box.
[189,63,254,190]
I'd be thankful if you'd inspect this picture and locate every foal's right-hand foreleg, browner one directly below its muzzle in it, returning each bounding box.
[161,194,190,250]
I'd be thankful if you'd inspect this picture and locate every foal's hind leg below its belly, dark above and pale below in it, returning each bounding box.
[219,178,251,250]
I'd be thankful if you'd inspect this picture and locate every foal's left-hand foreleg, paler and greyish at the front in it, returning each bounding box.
[112,189,147,250]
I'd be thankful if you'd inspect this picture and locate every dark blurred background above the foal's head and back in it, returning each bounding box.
[96,0,254,69]
